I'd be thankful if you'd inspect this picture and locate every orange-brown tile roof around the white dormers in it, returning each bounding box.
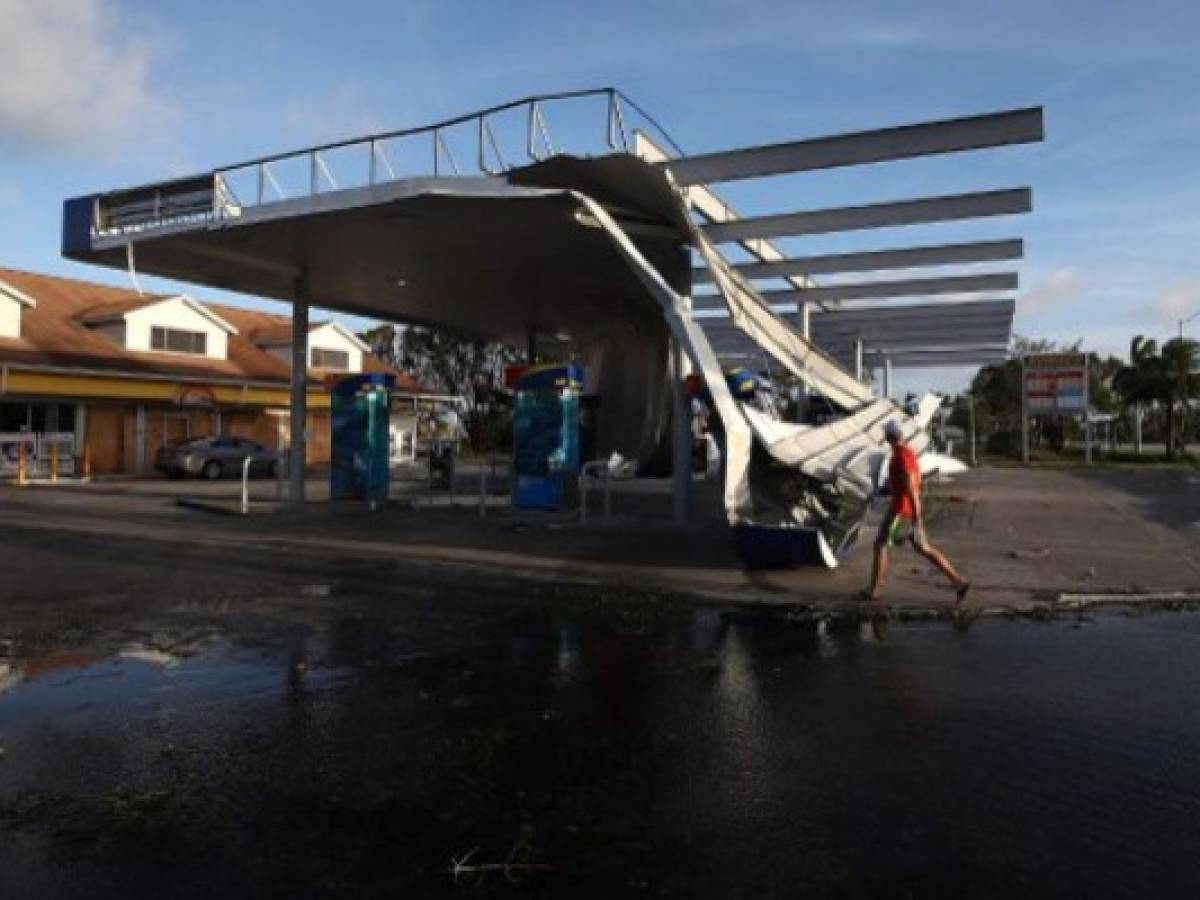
[0,268,432,394]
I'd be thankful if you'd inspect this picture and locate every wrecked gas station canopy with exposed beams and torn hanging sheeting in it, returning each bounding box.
[62,89,1043,520]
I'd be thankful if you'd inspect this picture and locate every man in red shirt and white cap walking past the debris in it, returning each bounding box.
[865,420,971,605]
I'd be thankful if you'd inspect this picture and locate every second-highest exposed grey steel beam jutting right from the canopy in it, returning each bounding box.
[703,187,1033,244]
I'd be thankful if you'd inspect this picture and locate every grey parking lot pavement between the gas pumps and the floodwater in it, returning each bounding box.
[0,468,1200,608]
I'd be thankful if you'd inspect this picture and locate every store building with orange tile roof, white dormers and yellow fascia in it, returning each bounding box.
[0,268,436,476]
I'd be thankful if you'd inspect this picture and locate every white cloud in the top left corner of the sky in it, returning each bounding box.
[0,0,169,152]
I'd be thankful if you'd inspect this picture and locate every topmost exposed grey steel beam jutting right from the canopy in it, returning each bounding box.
[667,107,1045,186]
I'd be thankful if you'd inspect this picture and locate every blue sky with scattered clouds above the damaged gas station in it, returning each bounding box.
[0,0,1200,393]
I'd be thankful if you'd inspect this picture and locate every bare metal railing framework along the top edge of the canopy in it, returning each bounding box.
[94,88,683,236]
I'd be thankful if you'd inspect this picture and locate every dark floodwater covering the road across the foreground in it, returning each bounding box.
[0,584,1200,899]
